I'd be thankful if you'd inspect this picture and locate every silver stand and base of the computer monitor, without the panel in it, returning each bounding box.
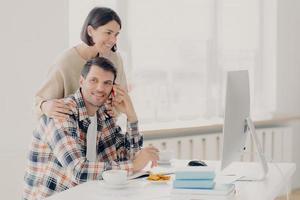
[221,117,269,181]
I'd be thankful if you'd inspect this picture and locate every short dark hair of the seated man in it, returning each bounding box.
[81,57,117,82]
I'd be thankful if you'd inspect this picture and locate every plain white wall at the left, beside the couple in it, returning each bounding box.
[0,0,68,199]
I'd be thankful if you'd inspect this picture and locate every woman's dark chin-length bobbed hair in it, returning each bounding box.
[80,7,122,52]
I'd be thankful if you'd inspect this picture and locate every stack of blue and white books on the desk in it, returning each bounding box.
[171,167,235,200]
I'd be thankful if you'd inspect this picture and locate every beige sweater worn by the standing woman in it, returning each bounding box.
[34,47,127,118]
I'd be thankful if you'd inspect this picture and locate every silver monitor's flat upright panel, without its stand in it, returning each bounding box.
[221,70,250,169]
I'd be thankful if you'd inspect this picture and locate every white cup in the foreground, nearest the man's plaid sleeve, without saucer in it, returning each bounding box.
[102,169,127,185]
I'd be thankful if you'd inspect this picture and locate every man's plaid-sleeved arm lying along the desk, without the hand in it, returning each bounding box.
[48,119,132,183]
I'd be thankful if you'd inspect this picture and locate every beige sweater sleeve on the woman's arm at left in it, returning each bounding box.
[34,69,64,119]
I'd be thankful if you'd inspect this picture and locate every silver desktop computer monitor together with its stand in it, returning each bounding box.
[221,70,268,180]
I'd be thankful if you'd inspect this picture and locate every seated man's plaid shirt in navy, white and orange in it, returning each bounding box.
[23,89,143,200]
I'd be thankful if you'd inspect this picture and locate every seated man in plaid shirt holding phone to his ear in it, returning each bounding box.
[23,57,158,200]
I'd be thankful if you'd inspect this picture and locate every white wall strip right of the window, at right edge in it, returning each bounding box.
[276,0,300,188]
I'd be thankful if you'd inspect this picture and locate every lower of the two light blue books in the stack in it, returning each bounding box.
[173,179,215,189]
